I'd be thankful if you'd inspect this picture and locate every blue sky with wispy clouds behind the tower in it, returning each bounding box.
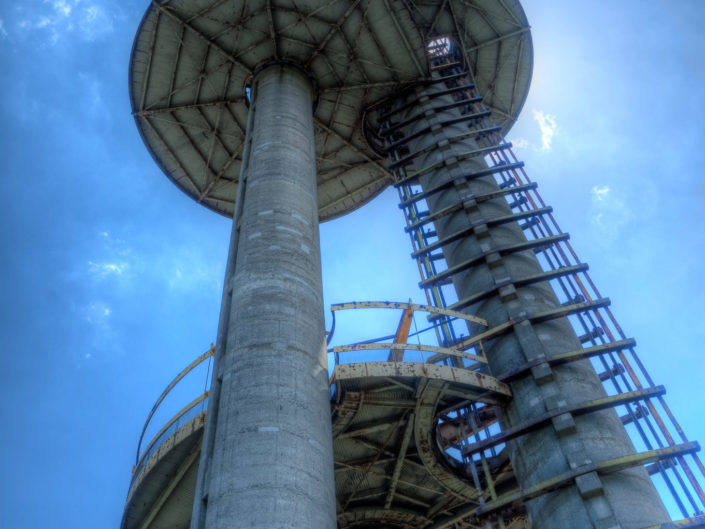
[0,0,705,529]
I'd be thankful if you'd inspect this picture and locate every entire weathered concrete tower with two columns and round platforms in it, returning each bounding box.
[122,0,705,529]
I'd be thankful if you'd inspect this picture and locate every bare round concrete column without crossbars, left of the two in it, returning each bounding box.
[192,64,336,529]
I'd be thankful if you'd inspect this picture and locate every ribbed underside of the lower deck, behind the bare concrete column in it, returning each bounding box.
[122,362,523,529]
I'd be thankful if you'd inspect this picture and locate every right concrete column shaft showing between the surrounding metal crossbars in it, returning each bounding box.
[395,80,669,529]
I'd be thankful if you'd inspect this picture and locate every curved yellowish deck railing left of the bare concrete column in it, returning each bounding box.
[132,344,215,478]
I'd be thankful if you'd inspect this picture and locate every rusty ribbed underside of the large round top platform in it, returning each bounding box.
[129,0,532,220]
